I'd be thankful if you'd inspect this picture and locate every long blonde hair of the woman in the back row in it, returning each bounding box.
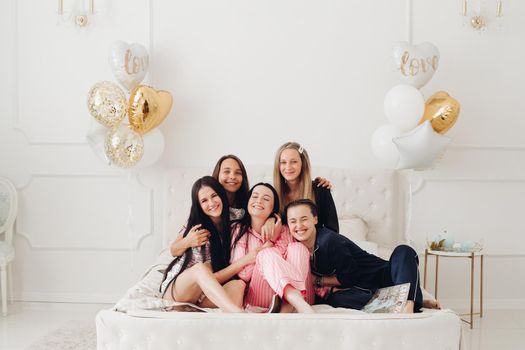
[273,142,315,213]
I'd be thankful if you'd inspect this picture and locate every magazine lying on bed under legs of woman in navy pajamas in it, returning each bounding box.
[361,283,410,314]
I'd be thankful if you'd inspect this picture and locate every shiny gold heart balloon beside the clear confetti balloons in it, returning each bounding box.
[128,85,173,135]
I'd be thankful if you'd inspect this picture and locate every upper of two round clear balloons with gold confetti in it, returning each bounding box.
[87,81,126,128]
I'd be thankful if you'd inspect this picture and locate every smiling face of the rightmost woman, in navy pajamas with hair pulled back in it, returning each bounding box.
[286,205,317,248]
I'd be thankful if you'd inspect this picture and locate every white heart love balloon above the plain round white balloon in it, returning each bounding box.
[393,41,439,89]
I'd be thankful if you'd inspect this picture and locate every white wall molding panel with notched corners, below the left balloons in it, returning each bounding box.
[16,174,154,251]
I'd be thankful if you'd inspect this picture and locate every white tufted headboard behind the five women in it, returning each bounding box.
[163,165,405,248]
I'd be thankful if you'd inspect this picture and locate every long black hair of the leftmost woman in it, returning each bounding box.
[163,176,231,288]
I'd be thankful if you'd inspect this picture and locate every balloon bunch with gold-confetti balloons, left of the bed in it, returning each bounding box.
[86,41,173,168]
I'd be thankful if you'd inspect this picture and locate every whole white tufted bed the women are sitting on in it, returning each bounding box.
[96,165,464,350]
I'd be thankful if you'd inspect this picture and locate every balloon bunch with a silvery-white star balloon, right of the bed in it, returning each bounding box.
[371,42,459,170]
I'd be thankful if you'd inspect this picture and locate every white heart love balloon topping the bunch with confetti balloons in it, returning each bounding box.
[108,41,149,90]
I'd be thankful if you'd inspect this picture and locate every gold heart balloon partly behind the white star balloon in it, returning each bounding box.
[419,91,459,134]
